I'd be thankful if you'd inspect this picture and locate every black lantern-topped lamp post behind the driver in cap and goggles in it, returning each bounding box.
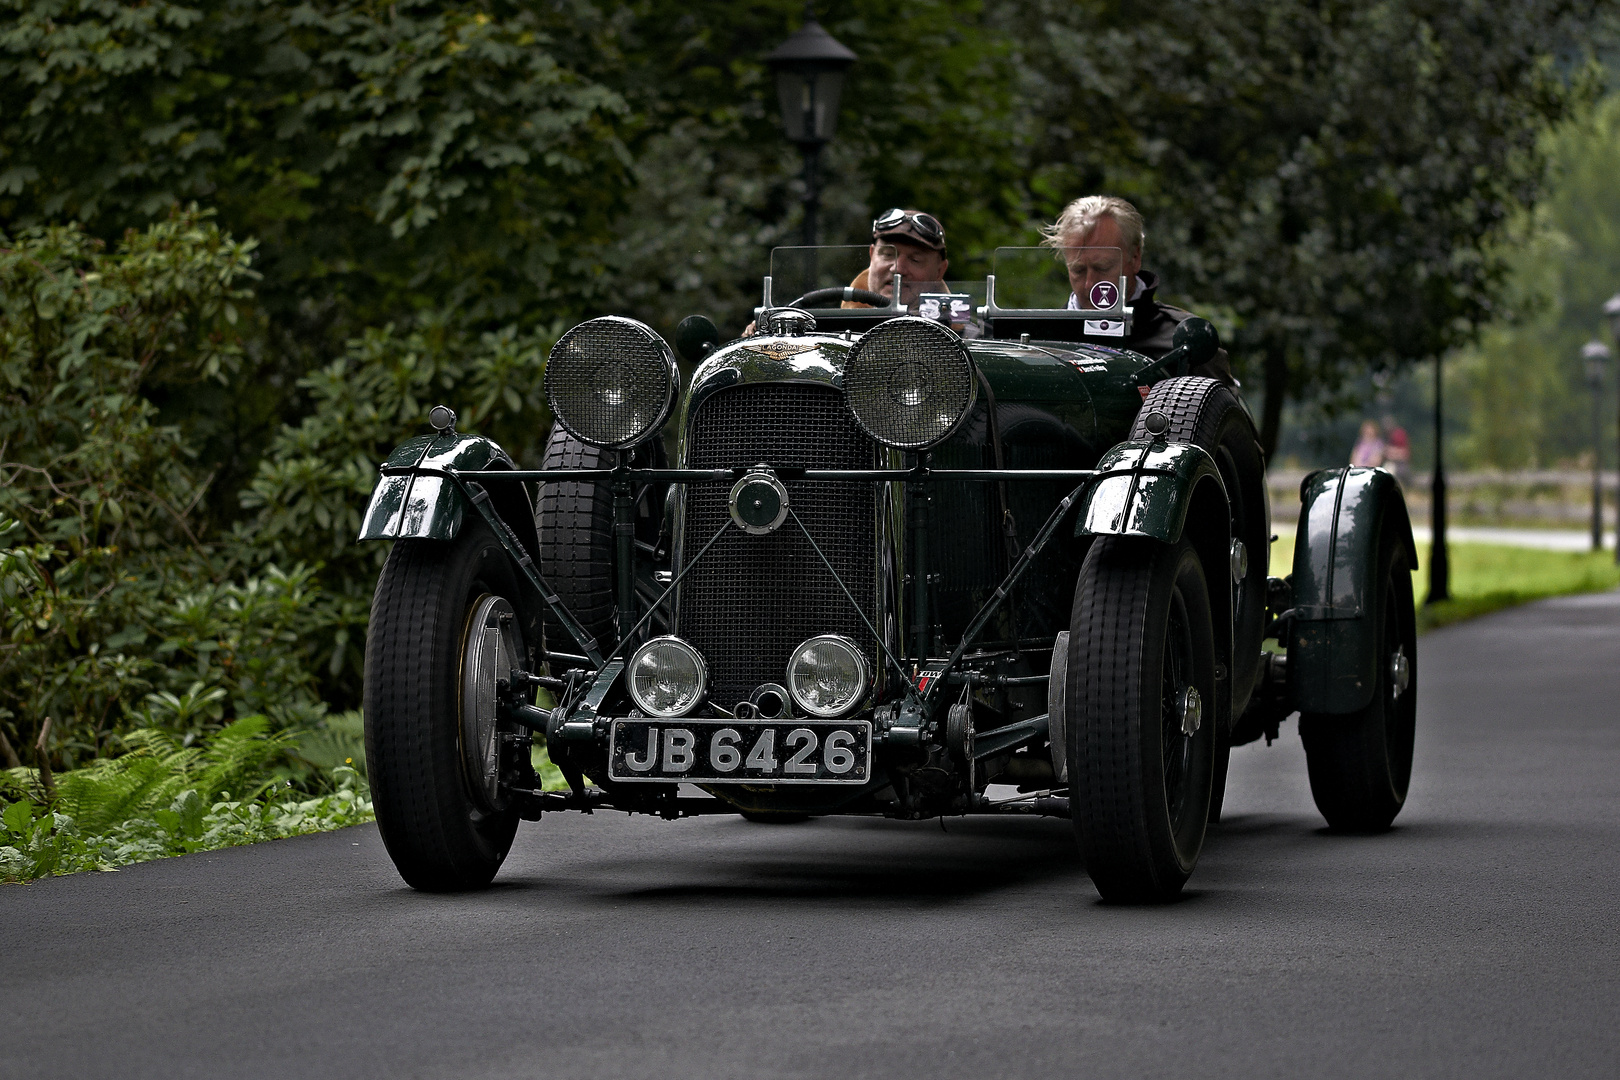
[765,3,855,248]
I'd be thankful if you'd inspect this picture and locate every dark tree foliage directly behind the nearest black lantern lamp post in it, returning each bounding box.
[579,0,1027,332]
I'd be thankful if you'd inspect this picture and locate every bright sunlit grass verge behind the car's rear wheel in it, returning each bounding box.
[1272,534,1620,633]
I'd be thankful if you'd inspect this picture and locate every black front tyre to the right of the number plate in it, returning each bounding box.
[1064,536,1217,904]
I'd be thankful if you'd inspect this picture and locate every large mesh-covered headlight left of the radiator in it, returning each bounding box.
[546,316,680,450]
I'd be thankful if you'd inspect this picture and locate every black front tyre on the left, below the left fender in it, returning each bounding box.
[365,520,525,892]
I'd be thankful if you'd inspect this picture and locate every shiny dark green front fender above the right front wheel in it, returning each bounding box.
[1074,442,1226,544]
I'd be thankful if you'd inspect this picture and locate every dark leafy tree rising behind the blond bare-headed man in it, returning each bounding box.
[1009,0,1596,452]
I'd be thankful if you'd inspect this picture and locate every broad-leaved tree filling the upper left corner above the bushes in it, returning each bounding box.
[0,0,627,521]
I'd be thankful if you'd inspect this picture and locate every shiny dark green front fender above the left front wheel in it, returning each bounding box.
[360,432,539,555]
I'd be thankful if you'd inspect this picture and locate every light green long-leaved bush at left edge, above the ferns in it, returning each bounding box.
[0,209,285,769]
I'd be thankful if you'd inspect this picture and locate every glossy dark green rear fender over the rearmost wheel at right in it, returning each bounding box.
[1286,466,1418,714]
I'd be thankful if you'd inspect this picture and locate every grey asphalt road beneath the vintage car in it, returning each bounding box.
[0,593,1620,1080]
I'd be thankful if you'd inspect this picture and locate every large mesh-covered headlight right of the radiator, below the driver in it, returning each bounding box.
[844,316,978,450]
